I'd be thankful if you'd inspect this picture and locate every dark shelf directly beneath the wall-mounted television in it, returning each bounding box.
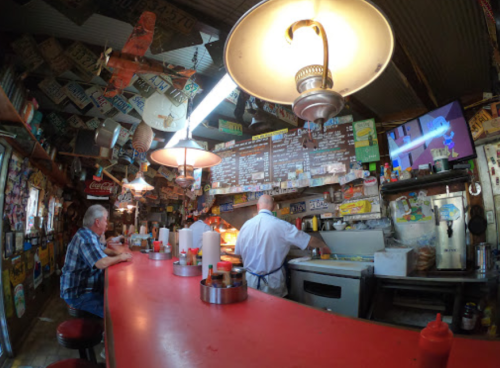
[381,170,469,194]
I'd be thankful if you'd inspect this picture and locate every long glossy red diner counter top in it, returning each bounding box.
[105,252,500,368]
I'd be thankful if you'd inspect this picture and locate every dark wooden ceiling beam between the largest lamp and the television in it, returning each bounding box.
[392,40,438,110]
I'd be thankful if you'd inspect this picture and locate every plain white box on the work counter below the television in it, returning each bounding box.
[374,248,415,276]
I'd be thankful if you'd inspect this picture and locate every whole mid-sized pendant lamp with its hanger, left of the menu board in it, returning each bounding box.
[150,100,222,188]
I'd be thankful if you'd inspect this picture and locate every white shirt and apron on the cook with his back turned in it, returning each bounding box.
[234,210,311,296]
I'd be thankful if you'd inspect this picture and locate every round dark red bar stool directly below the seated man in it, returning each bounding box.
[57,318,103,363]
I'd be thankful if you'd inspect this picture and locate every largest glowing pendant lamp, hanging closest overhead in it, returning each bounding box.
[224,0,394,123]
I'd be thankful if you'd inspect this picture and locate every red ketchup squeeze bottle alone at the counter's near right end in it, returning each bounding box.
[418,313,453,368]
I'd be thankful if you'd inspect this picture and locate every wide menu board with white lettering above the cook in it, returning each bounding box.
[210,124,356,191]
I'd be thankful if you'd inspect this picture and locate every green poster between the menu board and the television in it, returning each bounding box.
[352,119,380,162]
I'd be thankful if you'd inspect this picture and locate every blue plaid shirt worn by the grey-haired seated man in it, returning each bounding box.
[61,227,107,299]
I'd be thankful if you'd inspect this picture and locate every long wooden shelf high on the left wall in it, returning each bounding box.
[0,88,68,187]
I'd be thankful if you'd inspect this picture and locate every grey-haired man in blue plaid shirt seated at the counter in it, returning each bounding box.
[61,204,132,318]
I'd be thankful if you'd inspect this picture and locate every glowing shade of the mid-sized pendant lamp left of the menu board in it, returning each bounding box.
[150,139,222,169]
